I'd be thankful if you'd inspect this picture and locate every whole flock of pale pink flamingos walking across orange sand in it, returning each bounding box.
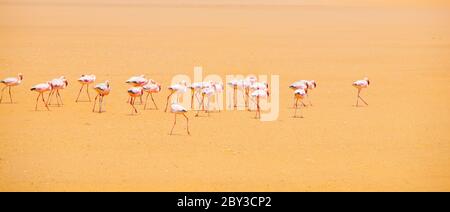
[0,73,370,135]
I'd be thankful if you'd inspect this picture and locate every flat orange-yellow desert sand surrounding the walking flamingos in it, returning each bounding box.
[0,0,450,191]
